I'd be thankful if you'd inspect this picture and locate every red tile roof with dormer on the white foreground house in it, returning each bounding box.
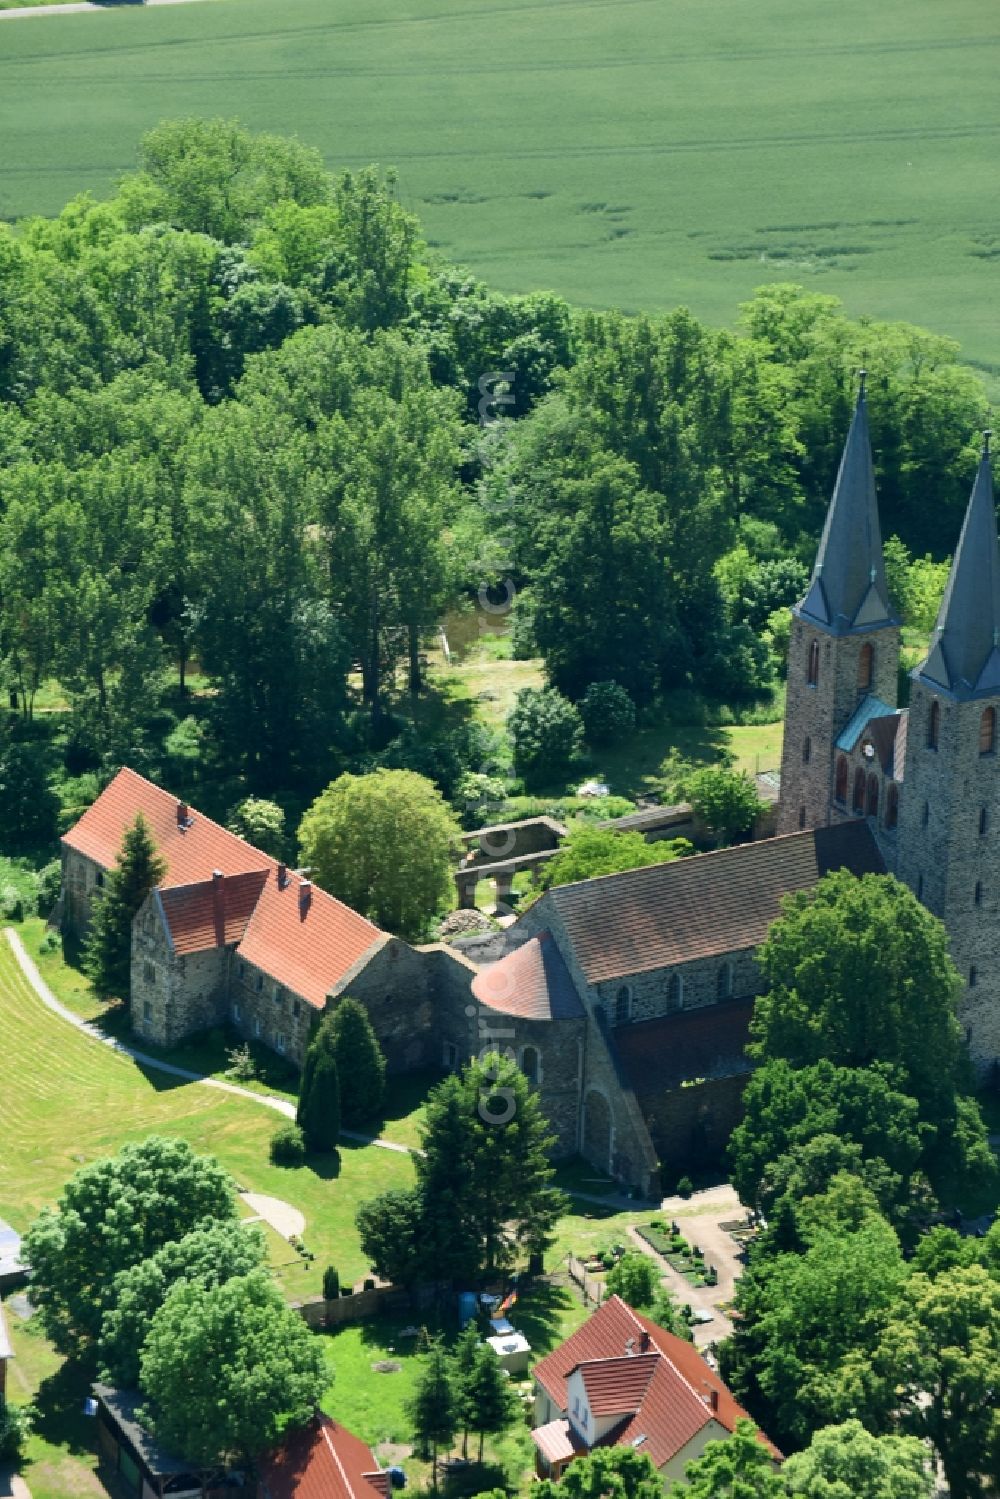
[532,1295,780,1468]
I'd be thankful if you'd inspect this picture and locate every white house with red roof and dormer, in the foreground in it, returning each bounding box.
[531,1297,781,1480]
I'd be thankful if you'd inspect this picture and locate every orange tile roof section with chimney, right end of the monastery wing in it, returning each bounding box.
[237,875,385,1009]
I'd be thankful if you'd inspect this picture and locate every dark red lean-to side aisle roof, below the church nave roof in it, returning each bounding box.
[610,998,754,1096]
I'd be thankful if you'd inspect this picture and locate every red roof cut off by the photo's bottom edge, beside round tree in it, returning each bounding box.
[258,1415,388,1499]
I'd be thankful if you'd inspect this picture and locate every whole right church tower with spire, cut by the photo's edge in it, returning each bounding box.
[897,433,1000,1069]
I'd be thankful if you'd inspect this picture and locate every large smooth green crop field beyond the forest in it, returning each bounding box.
[0,0,1000,378]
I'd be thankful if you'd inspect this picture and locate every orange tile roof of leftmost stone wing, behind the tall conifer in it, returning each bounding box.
[63,769,273,889]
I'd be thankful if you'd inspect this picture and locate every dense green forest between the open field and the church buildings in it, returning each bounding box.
[0,120,987,853]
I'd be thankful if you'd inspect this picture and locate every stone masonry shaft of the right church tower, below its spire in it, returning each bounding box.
[898,682,1000,1076]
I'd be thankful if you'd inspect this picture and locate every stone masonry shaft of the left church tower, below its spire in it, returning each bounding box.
[778,615,900,833]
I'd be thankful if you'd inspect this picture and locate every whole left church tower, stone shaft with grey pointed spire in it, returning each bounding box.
[778,372,900,833]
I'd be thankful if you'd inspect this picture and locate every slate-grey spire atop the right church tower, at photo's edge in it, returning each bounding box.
[913,432,1000,697]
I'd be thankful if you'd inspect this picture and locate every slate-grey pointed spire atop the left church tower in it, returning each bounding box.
[796,370,897,636]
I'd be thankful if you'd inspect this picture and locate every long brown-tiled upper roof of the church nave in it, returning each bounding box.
[546,821,885,983]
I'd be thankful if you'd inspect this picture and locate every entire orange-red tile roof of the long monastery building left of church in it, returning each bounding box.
[63,769,385,1009]
